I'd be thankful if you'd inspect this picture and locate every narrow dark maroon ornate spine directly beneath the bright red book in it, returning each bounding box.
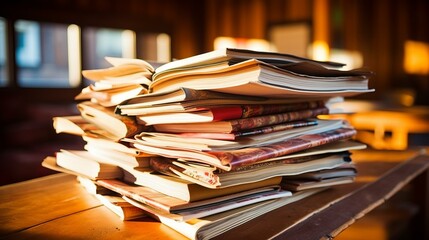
[230,107,329,132]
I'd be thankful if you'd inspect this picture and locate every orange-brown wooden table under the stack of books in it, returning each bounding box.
[0,150,429,240]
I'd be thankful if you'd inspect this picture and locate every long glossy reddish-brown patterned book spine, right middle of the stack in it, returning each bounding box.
[207,128,356,170]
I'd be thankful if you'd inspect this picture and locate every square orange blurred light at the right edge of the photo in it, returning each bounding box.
[404,41,429,75]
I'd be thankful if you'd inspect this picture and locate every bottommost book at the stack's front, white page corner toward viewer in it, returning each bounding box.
[141,188,324,240]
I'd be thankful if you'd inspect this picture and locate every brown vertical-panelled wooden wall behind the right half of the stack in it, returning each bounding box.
[204,0,429,105]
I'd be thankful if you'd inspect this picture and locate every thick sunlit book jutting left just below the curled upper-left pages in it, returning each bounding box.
[77,101,147,140]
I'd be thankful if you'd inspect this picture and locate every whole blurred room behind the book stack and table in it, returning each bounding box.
[0,0,429,184]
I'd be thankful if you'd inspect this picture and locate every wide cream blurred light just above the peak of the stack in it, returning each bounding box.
[214,37,273,51]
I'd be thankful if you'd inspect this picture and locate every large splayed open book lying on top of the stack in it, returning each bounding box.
[88,48,373,101]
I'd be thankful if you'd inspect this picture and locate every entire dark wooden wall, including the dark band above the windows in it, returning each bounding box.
[0,0,429,103]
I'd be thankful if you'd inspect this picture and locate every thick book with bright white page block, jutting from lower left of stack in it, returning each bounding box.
[55,149,123,179]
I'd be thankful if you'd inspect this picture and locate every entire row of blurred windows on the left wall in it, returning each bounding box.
[0,18,170,91]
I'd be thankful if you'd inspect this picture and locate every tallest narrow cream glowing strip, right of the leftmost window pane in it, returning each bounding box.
[67,24,82,87]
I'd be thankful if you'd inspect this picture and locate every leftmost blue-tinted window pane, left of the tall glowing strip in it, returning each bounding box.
[15,20,72,88]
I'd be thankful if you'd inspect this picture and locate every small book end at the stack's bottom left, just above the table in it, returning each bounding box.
[95,194,146,221]
